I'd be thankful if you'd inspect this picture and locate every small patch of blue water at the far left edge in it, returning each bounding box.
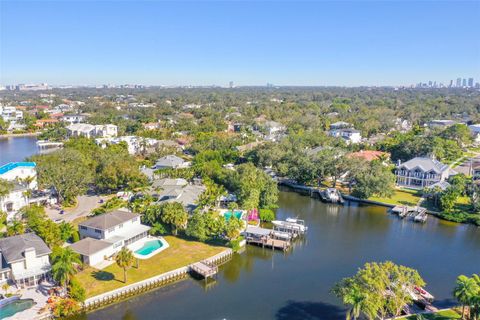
[0,137,38,166]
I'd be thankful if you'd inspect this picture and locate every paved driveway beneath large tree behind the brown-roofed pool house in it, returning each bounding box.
[45,195,110,222]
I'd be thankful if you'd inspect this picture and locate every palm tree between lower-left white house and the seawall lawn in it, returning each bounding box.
[51,247,82,290]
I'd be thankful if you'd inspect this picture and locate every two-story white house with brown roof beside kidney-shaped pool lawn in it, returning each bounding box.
[70,210,150,266]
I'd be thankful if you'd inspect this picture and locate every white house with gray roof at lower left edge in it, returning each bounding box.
[0,233,52,287]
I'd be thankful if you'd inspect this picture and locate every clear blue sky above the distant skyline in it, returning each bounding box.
[0,0,480,86]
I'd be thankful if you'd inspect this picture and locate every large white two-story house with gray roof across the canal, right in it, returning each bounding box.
[395,157,451,189]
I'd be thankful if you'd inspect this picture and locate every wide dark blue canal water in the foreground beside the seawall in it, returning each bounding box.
[76,191,480,320]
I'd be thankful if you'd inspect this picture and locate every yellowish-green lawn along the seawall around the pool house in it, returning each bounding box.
[75,236,225,297]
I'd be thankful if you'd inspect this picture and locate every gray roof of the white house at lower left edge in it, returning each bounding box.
[0,233,52,263]
